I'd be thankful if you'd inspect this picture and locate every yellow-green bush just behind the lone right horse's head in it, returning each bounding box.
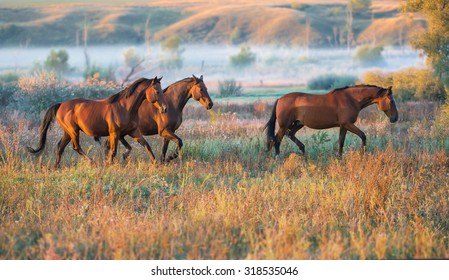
[362,67,446,101]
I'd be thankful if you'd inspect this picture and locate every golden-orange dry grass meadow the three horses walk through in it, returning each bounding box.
[0,97,449,259]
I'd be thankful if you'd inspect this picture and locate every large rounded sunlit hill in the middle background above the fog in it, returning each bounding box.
[155,6,316,44]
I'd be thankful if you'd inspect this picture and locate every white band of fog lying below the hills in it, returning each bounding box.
[0,45,425,86]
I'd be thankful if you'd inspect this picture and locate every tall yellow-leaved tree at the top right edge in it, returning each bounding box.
[405,0,449,88]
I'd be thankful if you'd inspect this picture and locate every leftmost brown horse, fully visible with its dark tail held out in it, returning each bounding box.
[27,77,167,168]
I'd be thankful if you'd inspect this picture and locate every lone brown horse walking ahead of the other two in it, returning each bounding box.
[265,85,398,158]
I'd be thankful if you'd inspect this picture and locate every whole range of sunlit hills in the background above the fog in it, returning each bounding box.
[0,0,424,47]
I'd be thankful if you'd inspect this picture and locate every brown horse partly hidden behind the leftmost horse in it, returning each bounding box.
[96,75,214,161]
